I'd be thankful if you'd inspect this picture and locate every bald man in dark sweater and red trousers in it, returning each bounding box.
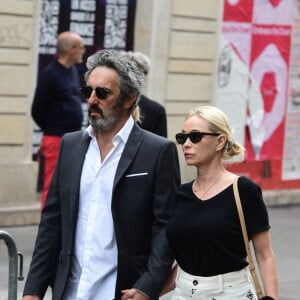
[31,32,84,211]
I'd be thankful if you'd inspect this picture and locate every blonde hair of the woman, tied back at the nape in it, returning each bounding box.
[186,105,245,159]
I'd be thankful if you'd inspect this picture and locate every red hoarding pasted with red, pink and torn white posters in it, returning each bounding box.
[218,0,300,190]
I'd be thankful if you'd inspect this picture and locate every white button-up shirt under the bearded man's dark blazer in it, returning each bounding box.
[63,117,134,300]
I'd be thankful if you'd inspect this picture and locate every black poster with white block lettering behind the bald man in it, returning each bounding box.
[39,0,136,80]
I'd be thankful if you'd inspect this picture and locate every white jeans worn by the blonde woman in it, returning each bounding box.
[170,268,258,300]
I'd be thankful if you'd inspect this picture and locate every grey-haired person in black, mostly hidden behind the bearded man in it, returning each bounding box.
[124,51,167,137]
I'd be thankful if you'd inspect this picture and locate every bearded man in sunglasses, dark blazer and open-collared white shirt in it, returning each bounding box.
[23,50,180,300]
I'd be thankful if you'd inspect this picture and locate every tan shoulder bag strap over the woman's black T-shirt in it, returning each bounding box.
[233,176,263,299]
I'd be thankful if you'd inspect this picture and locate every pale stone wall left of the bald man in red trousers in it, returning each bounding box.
[0,0,39,225]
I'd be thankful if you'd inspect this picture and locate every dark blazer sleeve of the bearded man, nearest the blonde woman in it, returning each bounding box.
[133,142,180,299]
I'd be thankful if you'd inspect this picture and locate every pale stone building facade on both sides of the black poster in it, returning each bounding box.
[0,0,227,226]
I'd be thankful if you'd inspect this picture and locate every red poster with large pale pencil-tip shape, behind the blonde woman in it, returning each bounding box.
[247,24,291,160]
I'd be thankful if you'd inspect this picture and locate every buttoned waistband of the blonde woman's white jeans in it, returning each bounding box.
[176,268,250,290]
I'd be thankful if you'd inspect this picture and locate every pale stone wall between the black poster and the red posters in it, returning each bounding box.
[135,0,223,182]
